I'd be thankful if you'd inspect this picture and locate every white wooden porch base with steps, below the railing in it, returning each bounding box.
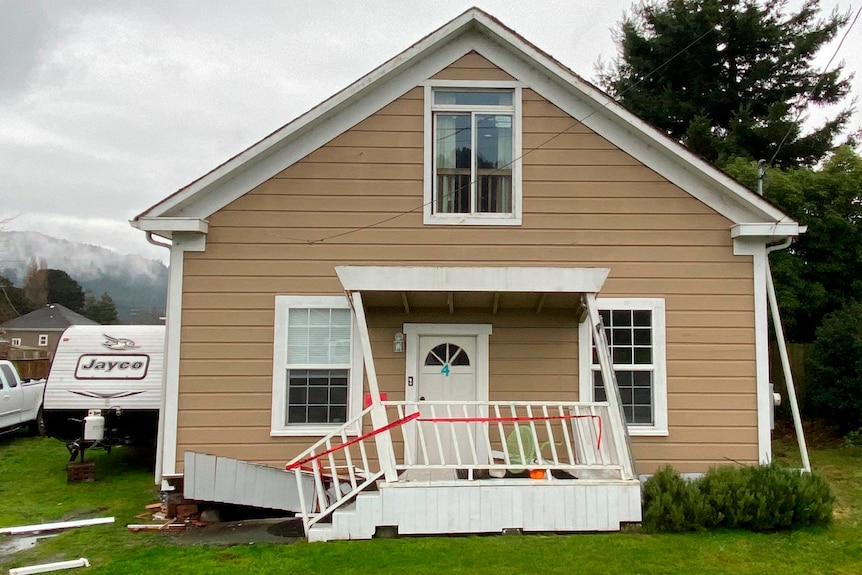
[308,480,641,541]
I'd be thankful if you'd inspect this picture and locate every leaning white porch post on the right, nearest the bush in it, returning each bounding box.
[583,293,636,479]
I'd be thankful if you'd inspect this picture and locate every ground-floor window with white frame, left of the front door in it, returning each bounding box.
[271,296,362,435]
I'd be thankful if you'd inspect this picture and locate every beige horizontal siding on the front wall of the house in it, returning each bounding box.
[177,54,757,472]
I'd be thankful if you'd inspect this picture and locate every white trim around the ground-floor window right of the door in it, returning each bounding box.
[578,298,668,437]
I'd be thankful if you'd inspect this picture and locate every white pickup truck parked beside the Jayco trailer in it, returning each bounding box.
[0,360,45,435]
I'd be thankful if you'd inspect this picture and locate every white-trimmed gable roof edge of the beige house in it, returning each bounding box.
[130,8,799,238]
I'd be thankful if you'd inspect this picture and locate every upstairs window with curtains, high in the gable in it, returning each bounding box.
[425,85,521,225]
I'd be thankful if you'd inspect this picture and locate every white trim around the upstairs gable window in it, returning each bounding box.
[423,80,523,226]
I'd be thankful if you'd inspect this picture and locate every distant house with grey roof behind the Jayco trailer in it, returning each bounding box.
[0,303,99,359]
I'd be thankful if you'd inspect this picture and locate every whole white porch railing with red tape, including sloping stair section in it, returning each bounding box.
[285,401,631,533]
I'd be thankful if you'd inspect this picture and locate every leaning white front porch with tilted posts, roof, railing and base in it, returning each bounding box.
[286,267,641,540]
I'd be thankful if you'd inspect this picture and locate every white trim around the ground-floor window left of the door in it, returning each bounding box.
[269,295,364,437]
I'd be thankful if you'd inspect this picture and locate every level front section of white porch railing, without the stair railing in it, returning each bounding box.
[383,401,629,481]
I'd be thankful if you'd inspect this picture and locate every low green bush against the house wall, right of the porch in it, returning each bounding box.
[643,464,835,532]
